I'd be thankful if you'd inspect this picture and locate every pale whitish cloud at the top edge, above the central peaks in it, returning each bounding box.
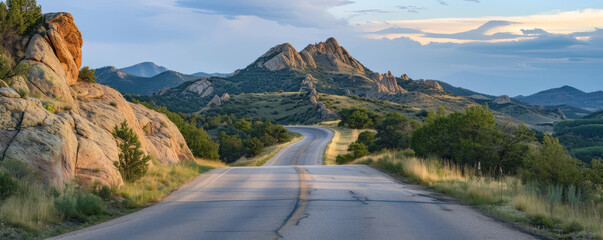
[176,0,353,28]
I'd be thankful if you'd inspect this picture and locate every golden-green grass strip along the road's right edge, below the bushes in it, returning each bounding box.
[354,152,603,239]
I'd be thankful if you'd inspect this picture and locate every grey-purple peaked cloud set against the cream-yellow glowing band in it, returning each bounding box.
[423,20,521,40]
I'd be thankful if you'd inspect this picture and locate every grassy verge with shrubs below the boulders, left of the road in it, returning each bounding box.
[0,159,226,239]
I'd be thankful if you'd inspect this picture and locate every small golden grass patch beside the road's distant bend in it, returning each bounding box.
[319,120,364,165]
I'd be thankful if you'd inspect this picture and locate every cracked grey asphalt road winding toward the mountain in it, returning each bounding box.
[50,127,533,240]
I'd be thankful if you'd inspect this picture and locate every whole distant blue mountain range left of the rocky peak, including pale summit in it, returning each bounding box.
[94,62,229,95]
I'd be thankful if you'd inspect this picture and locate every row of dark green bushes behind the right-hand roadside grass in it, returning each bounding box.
[336,106,603,189]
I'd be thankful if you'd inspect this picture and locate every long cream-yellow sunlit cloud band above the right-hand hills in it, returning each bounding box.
[359,9,603,44]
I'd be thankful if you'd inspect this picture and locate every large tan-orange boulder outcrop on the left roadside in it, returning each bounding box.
[0,13,193,188]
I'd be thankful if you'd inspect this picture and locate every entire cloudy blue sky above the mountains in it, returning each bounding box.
[38,0,603,96]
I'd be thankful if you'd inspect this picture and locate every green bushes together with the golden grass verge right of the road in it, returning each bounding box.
[337,106,603,237]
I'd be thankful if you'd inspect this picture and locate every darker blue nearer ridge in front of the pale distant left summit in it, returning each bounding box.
[94,66,199,95]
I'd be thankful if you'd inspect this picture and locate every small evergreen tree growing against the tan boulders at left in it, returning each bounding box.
[113,120,151,182]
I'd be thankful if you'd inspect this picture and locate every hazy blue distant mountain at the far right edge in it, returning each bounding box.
[516,86,603,111]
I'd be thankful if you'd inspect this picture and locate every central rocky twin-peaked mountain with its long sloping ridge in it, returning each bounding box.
[128,38,564,129]
